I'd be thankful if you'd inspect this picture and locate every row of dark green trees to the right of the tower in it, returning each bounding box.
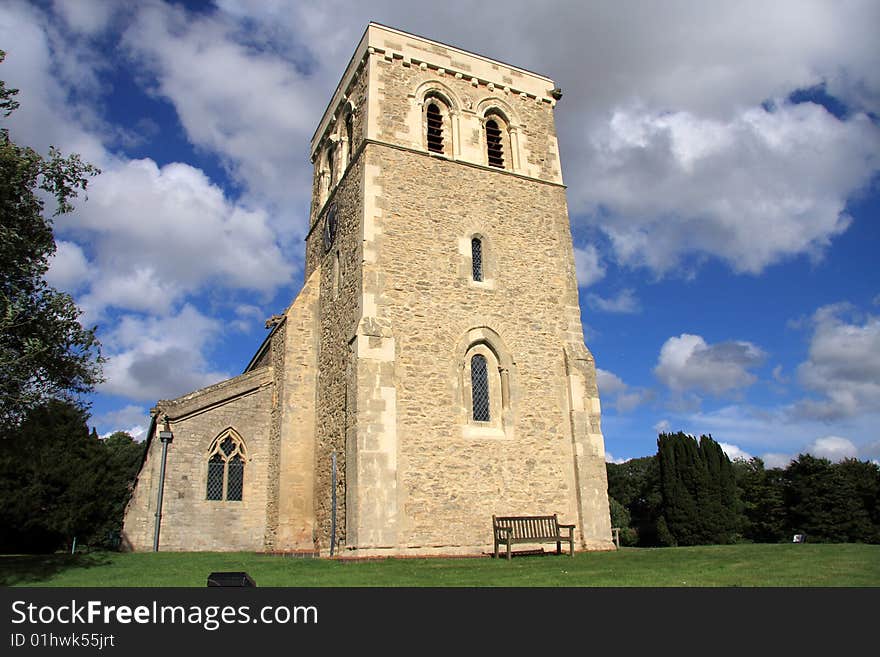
[606,432,880,546]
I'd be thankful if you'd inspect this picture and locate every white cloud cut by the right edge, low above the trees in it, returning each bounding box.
[797,304,880,419]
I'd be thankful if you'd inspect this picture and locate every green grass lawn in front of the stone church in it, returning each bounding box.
[0,544,880,587]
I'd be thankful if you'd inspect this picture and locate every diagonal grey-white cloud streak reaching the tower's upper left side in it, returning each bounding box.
[123,4,320,238]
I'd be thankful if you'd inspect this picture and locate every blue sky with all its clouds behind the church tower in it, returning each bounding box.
[0,0,880,465]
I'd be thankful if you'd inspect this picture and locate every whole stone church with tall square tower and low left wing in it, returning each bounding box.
[124,23,612,555]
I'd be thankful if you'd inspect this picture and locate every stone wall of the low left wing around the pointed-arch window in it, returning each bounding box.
[123,367,273,551]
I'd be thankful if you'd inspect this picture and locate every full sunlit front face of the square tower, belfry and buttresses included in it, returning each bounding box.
[336,32,611,553]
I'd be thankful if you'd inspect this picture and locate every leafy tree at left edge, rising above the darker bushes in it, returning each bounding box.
[0,51,102,427]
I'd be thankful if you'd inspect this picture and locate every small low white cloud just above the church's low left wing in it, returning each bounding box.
[99,305,230,401]
